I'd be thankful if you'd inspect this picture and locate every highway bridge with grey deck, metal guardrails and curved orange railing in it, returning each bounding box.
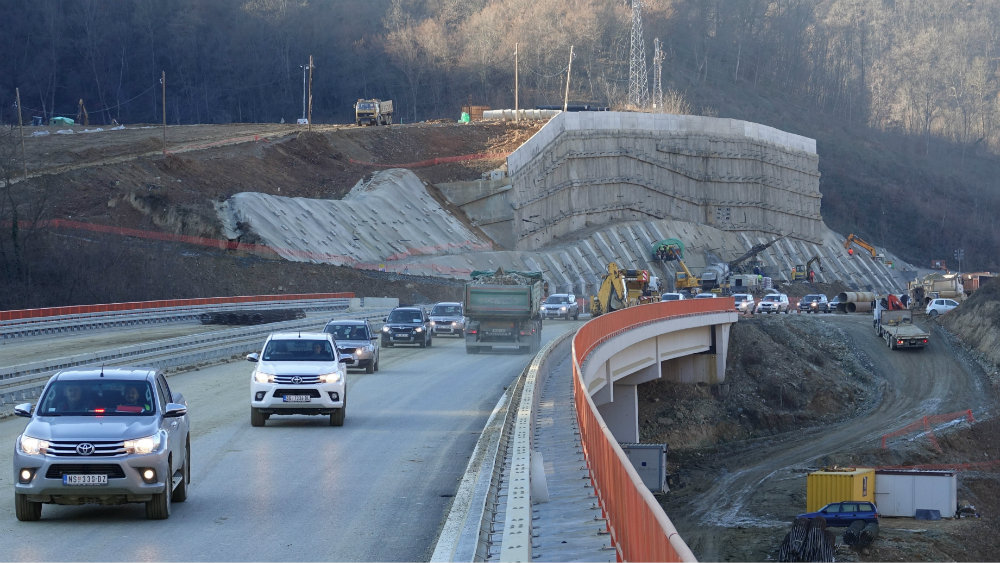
[0,296,736,561]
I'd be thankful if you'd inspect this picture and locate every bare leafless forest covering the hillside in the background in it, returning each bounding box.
[0,0,1000,270]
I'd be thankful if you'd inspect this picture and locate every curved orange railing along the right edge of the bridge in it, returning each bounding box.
[573,298,735,561]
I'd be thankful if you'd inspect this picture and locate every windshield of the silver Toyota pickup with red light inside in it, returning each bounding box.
[38,379,156,416]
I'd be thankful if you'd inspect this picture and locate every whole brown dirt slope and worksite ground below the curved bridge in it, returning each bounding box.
[639,314,1000,561]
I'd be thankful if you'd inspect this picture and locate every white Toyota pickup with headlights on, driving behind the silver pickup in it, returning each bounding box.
[247,332,351,426]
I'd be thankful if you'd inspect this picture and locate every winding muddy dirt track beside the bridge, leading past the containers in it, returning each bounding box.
[663,315,996,561]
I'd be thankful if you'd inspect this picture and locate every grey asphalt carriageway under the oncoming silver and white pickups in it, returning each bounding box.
[0,323,577,561]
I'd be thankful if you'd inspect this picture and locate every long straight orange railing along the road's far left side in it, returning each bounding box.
[0,291,354,321]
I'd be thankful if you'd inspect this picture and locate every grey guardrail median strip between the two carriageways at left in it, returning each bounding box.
[0,305,391,418]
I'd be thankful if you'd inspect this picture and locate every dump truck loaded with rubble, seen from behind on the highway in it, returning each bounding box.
[465,268,544,354]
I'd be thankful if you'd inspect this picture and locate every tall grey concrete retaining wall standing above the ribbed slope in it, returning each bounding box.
[507,112,825,250]
